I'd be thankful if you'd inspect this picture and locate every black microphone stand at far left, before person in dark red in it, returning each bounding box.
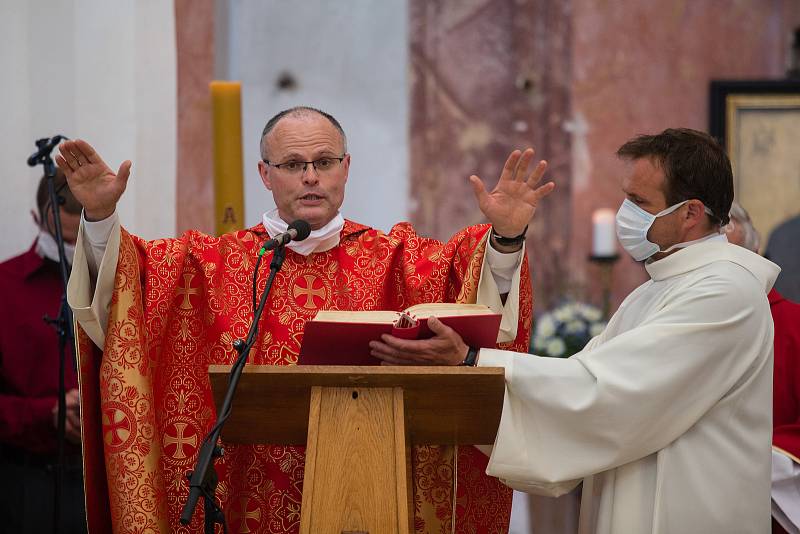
[28,135,75,533]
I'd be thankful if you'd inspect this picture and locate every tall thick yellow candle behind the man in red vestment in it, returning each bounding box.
[211,81,244,235]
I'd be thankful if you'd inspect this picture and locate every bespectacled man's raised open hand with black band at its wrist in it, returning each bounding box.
[469,148,556,237]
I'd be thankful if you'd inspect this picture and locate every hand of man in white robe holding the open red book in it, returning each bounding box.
[369,317,469,365]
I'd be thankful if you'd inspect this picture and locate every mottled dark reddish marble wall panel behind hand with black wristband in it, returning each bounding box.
[409,0,572,312]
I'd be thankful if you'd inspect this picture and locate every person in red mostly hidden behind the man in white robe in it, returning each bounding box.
[725,201,800,533]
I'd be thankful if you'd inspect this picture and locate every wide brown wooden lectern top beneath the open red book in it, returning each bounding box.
[208,365,505,445]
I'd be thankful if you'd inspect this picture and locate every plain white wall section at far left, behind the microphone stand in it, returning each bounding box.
[0,0,176,258]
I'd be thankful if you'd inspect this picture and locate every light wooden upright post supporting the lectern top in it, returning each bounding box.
[300,386,413,534]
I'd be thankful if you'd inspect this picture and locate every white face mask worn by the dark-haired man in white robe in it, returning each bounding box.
[617,198,714,261]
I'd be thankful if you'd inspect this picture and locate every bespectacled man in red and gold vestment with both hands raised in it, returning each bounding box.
[57,108,554,534]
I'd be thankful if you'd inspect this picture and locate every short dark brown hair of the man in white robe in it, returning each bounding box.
[617,128,733,225]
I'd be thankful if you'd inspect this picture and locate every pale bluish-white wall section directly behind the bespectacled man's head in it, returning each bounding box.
[222,0,409,230]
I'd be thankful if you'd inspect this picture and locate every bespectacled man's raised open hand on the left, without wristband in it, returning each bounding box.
[56,139,131,221]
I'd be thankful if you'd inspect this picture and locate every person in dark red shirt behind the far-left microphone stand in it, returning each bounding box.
[0,170,86,533]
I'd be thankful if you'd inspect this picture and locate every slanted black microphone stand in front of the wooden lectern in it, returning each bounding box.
[180,246,286,534]
